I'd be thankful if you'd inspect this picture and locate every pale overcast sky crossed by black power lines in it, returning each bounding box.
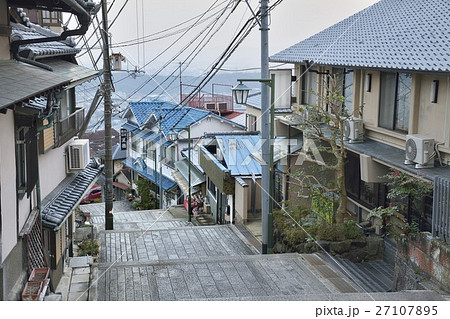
[80,0,378,75]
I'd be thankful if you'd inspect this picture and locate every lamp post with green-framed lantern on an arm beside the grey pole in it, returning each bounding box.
[232,74,275,254]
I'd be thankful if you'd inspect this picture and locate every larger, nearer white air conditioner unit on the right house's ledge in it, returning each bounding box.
[405,134,434,168]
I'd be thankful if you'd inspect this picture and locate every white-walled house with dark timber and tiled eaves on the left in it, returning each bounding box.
[0,0,101,300]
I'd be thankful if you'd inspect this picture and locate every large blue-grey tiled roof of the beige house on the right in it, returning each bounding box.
[270,0,450,72]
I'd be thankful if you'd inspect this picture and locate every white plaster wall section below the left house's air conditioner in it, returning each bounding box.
[39,139,73,199]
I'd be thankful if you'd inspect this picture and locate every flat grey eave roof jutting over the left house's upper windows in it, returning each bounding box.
[0,60,70,109]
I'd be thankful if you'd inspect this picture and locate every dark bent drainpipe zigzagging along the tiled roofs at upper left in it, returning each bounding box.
[10,0,91,71]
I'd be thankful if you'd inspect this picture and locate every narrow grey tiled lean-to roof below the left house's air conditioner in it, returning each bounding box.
[41,162,103,229]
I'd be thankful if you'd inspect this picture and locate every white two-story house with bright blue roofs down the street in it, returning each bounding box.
[123,101,245,207]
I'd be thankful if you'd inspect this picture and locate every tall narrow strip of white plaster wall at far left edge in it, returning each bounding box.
[0,110,17,262]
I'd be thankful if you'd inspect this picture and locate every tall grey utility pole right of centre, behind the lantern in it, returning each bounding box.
[260,0,274,254]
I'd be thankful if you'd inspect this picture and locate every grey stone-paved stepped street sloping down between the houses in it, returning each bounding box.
[76,204,435,301]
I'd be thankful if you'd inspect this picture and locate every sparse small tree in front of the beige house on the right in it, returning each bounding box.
[293,74,362,224]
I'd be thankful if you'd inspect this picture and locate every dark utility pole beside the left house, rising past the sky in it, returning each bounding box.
[102,0,114,230]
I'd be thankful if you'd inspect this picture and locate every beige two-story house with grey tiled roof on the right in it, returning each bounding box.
[271,0,450,241]
